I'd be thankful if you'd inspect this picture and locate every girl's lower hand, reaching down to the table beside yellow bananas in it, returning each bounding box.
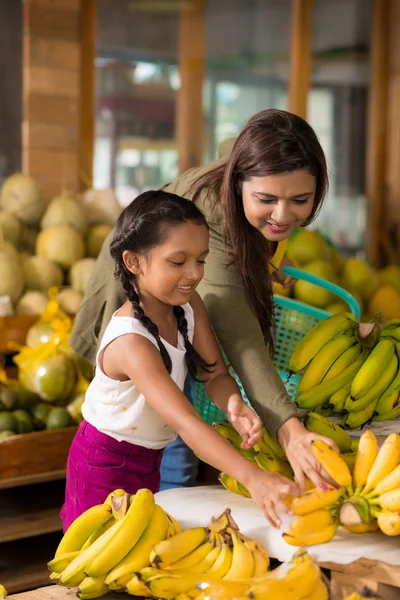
[246,469,299,529]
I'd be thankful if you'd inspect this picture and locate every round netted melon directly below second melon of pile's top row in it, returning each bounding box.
[36,226,85,270]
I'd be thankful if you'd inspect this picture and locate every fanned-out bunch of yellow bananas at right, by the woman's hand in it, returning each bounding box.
[283,431,400,546]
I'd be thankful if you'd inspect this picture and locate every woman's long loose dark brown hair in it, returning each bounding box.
[190,109,328,354]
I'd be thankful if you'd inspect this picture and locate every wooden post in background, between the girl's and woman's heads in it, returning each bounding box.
[176,0,205,173]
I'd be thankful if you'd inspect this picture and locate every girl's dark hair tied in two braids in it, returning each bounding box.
[110,190,214,379]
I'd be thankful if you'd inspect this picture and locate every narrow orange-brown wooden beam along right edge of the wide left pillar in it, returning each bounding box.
[79,0,97,189]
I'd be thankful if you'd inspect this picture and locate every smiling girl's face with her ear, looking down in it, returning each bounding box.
[124,223,208,306]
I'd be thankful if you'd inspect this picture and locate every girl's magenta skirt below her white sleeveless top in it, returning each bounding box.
[61,421,163,532]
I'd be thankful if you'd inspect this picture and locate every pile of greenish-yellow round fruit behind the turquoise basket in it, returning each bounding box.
[282,229,400,321]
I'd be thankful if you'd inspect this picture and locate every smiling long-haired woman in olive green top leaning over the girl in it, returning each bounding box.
[71,110,334,490]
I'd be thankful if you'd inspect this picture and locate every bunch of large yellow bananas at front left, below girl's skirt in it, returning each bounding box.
[48,489,181,600]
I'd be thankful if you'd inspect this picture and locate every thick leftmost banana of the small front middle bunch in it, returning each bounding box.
[150,527,208,569]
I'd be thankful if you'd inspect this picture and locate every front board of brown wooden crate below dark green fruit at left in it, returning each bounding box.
[0,427,77,483]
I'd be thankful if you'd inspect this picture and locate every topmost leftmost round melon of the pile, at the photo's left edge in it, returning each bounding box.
[0,173,46,225]
